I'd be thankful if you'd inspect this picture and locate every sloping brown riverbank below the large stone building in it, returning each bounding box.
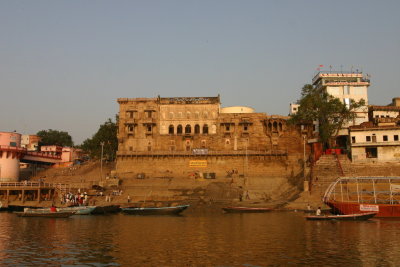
[21,161,320,209]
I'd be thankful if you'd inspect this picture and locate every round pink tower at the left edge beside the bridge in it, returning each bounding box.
[0,132,26,182]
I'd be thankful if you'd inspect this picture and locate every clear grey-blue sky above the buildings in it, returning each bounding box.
[0,0,400,144]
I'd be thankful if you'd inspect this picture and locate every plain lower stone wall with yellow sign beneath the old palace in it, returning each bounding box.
[116,155,301,180]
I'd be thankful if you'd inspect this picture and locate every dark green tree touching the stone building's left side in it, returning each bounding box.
[80,117,118,160]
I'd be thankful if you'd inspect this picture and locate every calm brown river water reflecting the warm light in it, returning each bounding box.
[0,212,400,267]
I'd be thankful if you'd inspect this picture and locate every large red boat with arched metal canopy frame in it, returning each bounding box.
[323,177,400,217]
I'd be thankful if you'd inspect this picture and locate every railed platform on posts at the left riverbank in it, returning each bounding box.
[0,181,69,207]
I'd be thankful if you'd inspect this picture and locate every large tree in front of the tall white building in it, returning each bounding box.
[290,84,365,148]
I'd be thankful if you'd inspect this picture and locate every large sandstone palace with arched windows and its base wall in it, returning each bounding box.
[116,96,304,181]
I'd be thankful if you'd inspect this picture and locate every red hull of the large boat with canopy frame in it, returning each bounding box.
[326,201,400,218]
